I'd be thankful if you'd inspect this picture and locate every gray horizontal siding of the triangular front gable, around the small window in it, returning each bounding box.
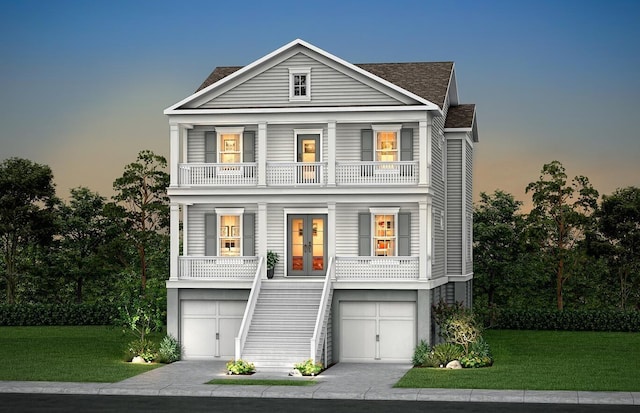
[201,53,401,108]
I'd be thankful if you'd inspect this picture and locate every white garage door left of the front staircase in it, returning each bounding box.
[180,300,246,360]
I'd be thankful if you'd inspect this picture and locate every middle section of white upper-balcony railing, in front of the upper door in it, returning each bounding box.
[267,162,327,186]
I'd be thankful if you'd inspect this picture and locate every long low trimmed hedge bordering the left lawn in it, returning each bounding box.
[0,303,118,326]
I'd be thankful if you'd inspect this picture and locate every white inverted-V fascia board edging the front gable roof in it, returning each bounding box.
[164,39,441,115]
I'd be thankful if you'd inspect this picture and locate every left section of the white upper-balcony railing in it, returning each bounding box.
[178,163,258,185]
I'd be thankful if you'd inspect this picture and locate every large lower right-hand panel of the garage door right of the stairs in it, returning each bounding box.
[380,320,416,361]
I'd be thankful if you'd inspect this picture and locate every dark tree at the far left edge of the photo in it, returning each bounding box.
[0,158,57,303]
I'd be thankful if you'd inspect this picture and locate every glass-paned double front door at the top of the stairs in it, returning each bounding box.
[287,215,327,276]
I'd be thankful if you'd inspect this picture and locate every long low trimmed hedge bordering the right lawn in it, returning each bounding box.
[484,308,640,332]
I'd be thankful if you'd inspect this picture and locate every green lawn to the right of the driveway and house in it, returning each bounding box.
[396,330,640,392]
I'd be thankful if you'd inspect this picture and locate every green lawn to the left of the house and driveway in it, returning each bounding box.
[0,326,161,383]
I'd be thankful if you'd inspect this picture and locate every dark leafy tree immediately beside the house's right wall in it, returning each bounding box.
[473,190,525,308]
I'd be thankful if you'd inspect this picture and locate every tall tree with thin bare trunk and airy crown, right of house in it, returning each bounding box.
[526,161,598,310]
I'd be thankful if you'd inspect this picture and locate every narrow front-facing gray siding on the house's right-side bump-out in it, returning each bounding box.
[446,139,463,275]
